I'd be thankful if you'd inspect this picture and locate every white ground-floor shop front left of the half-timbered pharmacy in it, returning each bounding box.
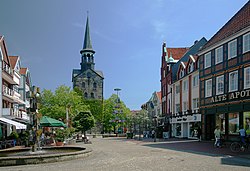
[170,114,201,139]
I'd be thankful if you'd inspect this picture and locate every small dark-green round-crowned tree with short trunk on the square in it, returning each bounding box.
[73,111,95,137]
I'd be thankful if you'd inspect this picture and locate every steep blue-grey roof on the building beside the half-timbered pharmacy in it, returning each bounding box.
[172,37,207,82]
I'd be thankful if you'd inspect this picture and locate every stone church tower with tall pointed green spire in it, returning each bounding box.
[72,16,104,100]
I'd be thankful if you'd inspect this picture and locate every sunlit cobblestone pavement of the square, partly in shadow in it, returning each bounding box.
[0,137,250,171]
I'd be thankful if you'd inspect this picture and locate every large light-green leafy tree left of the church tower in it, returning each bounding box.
[40,85,89,123]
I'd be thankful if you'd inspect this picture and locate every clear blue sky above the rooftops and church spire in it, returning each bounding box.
[0,0,247,110]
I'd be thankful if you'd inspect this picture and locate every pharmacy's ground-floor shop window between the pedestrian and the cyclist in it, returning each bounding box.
[228,113,239,135]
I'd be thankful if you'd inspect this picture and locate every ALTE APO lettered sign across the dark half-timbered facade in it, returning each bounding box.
[211,89,250,103]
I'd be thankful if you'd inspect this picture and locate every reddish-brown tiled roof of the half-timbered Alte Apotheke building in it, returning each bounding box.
[202,1,250,49]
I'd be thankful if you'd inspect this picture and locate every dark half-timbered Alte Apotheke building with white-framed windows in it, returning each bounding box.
[199,2,250,139]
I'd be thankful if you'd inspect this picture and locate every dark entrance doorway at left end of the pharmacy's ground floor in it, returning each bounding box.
[205,115,215,140]
